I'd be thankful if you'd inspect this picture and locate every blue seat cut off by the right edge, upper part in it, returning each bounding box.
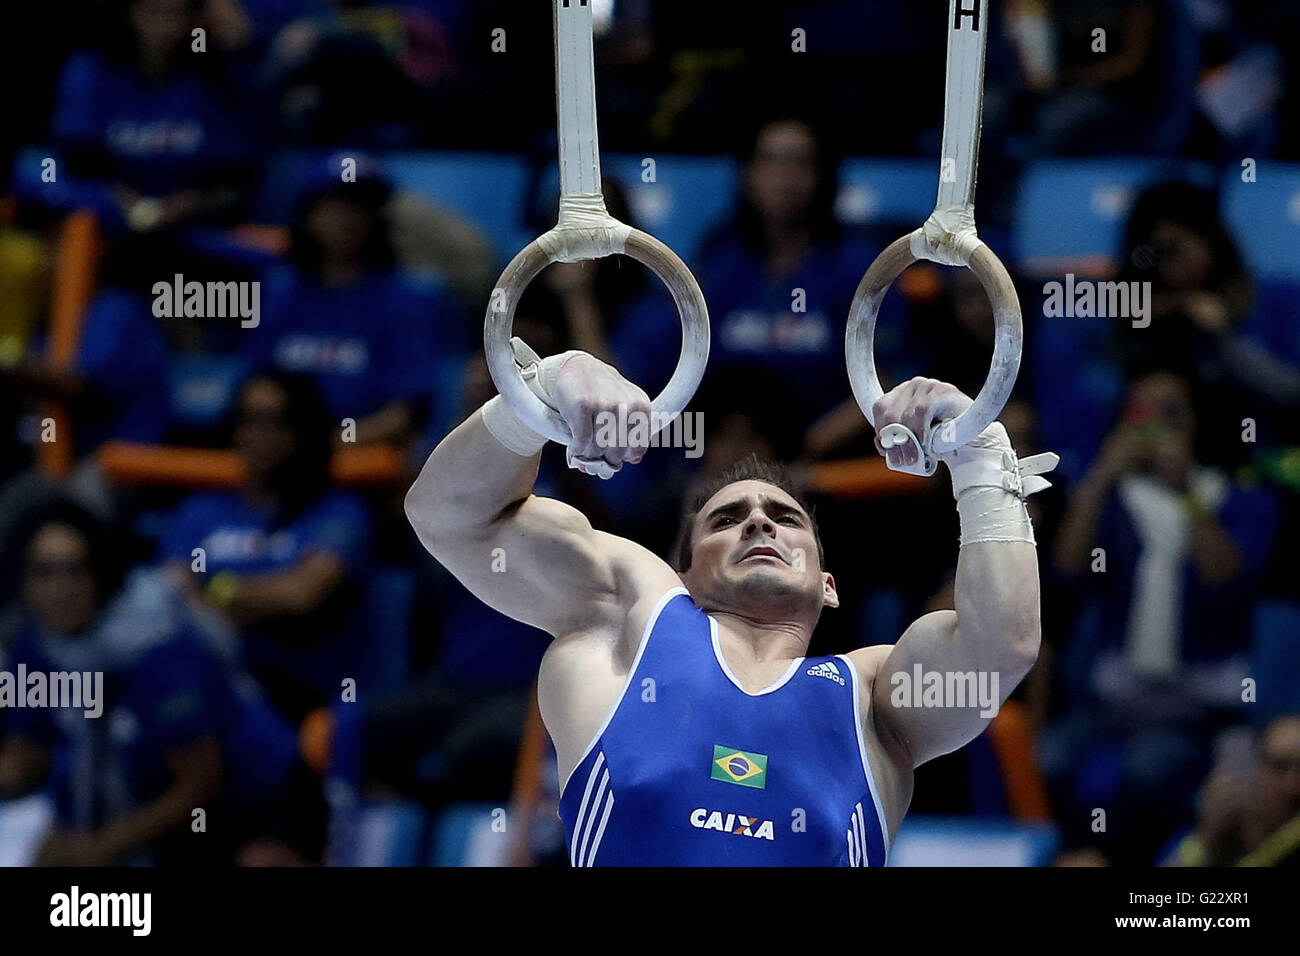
[1222,163,1300,280]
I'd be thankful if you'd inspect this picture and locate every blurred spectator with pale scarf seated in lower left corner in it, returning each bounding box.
[0,505,324,866]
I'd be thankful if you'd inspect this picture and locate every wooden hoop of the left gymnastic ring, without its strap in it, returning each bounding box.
[484,226,709,445]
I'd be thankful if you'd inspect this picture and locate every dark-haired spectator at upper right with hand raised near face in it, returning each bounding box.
[1031,182,1300,479]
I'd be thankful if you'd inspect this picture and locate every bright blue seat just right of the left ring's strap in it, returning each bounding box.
[528,153,736,265]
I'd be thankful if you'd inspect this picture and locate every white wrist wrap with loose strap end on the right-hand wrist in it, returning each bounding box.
[939,421,1061,545]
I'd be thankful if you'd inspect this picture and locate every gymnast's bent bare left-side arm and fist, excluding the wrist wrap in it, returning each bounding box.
[406,352,680,637]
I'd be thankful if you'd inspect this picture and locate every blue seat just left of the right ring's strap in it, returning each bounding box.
[835,159,939,231]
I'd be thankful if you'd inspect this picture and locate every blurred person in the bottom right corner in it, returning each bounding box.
[1175,714,1300,866]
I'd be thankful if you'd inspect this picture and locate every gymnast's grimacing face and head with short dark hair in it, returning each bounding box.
[681,480,839,617]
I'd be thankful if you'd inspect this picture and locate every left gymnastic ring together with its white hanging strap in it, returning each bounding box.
[484,0,709,445]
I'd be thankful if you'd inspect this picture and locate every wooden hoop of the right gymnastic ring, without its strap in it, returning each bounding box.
[844,229,1024,454]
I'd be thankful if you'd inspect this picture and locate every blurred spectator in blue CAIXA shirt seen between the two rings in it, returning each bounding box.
[614,118,904,457]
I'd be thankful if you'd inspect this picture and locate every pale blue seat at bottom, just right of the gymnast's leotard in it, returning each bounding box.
[889,816,1061,866]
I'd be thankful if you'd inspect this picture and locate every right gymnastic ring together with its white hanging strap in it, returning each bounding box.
[845,0,1024,475]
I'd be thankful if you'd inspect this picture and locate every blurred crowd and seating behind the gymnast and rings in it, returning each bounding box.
[0,0,1300,865]
